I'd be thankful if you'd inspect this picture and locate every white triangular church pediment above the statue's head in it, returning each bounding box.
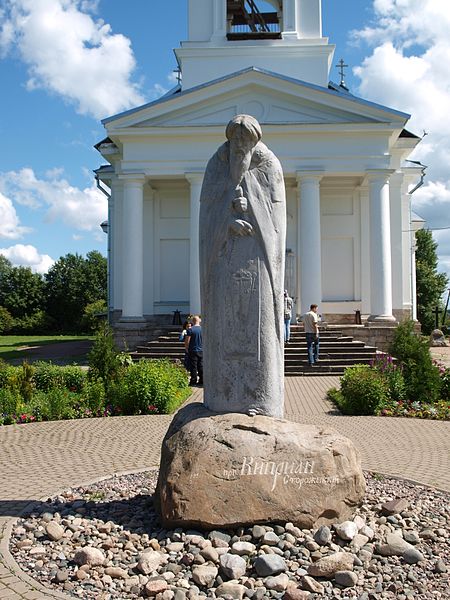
[104,69,408,130]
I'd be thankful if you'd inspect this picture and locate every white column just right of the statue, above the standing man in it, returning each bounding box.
[297,171,323,314]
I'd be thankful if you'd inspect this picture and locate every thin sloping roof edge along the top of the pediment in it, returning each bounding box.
[102,67,410,125]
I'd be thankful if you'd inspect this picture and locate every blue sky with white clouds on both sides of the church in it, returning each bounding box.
[0,0,450,286]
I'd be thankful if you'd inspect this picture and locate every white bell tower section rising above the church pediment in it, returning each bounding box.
[175,0,334,90]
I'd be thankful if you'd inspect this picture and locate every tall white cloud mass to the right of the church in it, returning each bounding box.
[353,0,450,278]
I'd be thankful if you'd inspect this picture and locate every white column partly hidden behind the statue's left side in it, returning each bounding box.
[185,173,203,315]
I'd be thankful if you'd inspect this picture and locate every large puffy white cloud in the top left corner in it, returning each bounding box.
[0,0,144,118]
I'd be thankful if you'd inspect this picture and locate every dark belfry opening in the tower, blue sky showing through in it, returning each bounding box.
[227,0,282,40]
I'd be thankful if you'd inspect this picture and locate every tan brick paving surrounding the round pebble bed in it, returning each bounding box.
[0,377,450,600]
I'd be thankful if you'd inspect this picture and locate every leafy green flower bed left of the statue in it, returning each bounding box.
[0,357,191,425]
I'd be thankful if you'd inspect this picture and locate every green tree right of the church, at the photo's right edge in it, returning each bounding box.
[416,229,448,333]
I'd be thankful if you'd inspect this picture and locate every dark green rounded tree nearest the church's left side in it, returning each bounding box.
[45,251,107,332]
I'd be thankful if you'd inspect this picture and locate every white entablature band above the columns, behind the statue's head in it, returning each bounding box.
[121,129,389,178]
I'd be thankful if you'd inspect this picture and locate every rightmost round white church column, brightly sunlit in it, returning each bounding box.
[367,170,395,321]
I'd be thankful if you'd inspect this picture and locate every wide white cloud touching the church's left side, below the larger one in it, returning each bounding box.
[0,168,108,233]
